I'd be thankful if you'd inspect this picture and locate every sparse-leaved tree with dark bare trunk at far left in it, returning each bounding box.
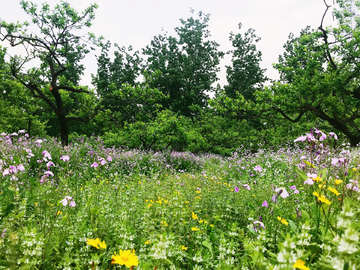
[0,0,97,146]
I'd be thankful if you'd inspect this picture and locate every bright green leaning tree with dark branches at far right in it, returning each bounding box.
[259,0,360,146]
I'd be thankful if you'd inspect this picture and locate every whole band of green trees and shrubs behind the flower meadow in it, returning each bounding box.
[0,0,360,152]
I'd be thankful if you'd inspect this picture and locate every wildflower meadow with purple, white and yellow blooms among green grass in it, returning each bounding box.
[0,129,360,270]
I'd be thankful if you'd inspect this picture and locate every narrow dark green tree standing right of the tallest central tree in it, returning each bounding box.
[224,23,267,100]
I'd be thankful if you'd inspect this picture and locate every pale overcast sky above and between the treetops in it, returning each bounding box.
[0,0,334,88]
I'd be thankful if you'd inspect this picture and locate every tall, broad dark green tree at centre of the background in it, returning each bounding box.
[143,12,224,116]
